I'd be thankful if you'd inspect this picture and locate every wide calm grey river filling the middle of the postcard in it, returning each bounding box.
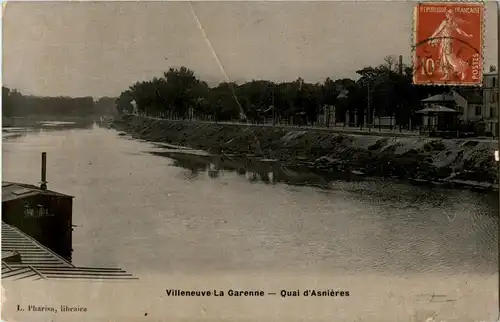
[3,122,498,320]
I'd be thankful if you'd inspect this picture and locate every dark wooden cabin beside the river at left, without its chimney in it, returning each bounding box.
[2,181,73,261]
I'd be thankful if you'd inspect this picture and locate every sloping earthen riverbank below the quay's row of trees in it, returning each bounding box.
[111,115,497,190]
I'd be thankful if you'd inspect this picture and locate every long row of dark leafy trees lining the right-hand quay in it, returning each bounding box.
[116,56,484,126]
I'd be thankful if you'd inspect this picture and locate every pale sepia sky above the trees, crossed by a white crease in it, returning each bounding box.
[2,1,497,97]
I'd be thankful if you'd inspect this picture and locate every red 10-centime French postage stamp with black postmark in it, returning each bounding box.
[413,2,484,86]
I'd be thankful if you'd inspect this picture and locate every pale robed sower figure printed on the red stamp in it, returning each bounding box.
[430,10,472,80]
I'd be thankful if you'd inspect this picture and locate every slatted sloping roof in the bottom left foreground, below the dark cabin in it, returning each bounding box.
[2,222,136,281]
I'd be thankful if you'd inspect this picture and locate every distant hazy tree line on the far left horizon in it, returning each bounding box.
[2,87,116,117]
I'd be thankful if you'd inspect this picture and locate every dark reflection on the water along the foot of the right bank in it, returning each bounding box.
[149,149,498,205]
